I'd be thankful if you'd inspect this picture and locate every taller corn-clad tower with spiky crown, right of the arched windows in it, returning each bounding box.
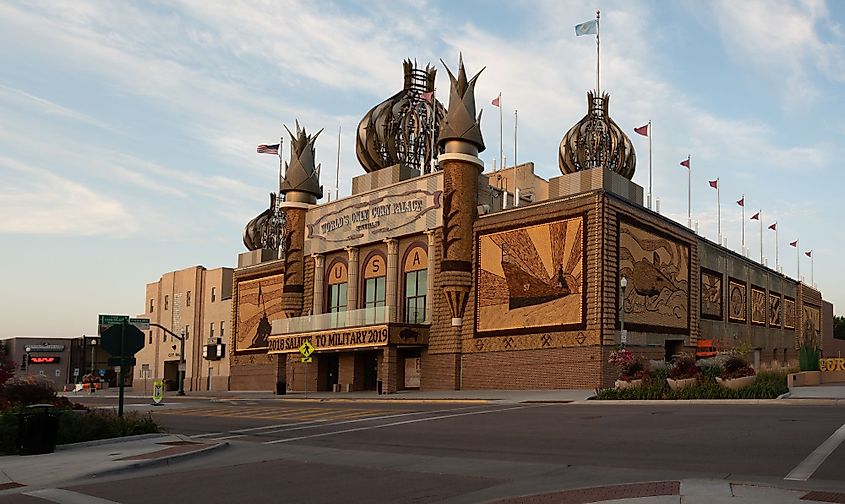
[438,58,484,352]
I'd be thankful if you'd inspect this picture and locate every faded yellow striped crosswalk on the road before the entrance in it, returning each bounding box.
[155,406,398,423]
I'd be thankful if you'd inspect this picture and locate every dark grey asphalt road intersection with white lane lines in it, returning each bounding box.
[2,400,845,504]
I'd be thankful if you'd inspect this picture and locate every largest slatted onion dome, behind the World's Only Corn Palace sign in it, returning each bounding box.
[355,60,446,173]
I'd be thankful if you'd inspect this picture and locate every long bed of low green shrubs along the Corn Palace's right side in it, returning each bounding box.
[596,366,789,400]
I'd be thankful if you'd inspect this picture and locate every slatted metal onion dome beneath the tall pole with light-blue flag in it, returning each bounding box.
[558,91,637,180]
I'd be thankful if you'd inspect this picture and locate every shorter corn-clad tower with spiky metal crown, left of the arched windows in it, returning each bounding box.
[279,122,323,318]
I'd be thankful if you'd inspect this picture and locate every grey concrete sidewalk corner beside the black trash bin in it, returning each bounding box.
[0,434,228,495]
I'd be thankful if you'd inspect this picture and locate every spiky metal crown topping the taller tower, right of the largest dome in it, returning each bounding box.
[437,57,484,152]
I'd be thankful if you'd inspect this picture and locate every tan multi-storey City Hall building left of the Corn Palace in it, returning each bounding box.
[132,266,233,392]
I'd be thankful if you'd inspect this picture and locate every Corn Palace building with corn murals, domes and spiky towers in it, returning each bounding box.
[229,58,824,393]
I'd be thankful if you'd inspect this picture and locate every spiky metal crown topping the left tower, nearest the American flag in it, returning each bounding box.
[279,121,323,203]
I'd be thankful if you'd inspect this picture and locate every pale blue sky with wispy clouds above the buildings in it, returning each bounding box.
[0,0,845,337]
